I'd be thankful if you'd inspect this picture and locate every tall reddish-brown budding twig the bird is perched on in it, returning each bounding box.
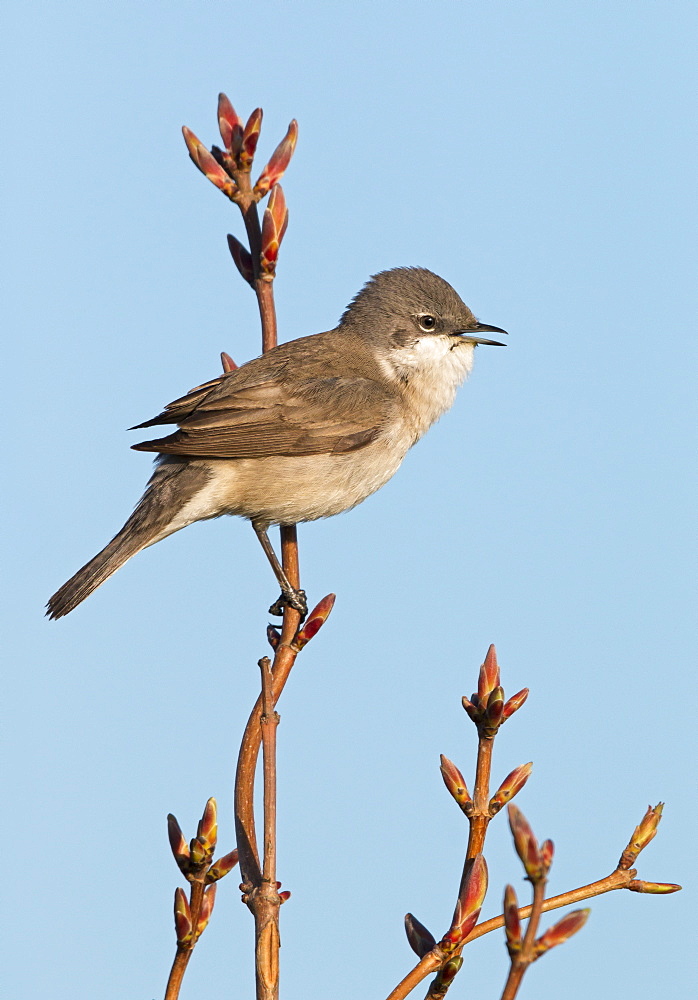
[183,94,300,1000]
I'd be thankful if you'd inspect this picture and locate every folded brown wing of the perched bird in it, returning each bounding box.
[133,370,393,458]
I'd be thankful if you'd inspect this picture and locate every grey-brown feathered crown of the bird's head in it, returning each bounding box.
[339,267,476,336]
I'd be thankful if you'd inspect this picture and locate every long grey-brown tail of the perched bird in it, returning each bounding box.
[46,459,213,618]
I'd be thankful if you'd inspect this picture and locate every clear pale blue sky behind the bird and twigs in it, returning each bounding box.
[1,0,698,1000]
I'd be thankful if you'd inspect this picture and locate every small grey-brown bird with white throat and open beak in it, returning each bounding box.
[46,267,506,619]
